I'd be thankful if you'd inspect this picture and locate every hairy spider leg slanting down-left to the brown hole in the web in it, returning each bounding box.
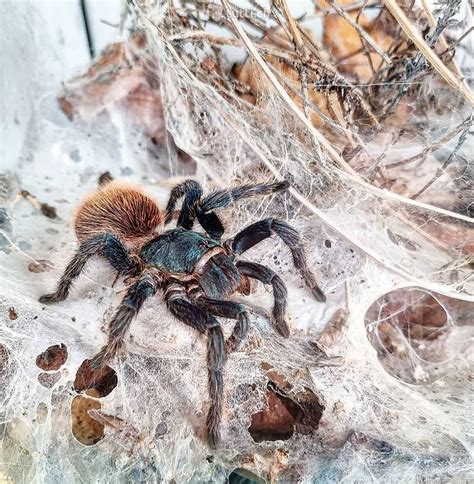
[91,273,158,368]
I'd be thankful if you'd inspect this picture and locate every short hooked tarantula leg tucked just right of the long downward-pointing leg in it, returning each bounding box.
[188,285,249,353]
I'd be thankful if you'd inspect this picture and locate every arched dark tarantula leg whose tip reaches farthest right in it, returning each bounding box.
[231,218,326,302]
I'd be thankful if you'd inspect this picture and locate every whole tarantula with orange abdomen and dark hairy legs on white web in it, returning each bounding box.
[39,179,325,448]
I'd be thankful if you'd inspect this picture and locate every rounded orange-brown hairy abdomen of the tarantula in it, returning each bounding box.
[74,181,164,244]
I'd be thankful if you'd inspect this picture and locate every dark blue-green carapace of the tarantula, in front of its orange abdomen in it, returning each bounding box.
[140,229,220,274]
